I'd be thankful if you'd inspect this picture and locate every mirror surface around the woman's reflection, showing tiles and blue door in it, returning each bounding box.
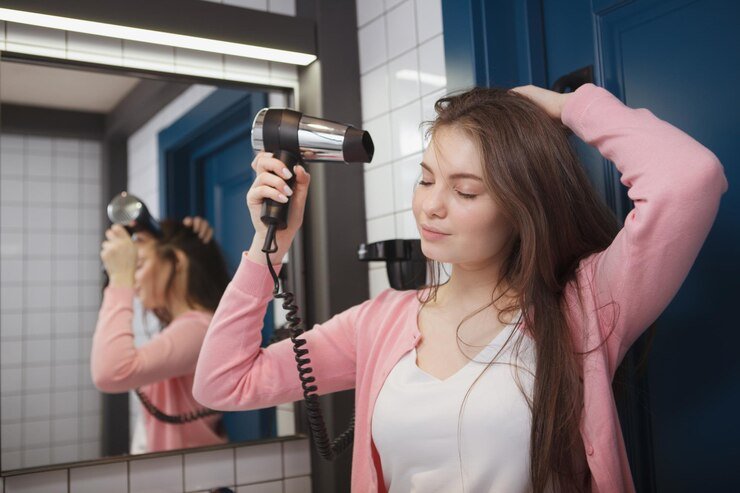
[0,55,295,472]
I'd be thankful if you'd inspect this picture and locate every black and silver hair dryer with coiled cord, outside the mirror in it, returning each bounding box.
[252,108,375,460]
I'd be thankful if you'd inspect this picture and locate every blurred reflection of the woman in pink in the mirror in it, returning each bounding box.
[90,218,229,453]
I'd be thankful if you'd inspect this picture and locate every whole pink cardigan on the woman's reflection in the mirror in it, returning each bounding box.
[90,287,226,452]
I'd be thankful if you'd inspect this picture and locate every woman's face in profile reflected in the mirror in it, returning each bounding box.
[134,238,172,310]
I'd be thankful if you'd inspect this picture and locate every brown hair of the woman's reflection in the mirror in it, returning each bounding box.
[153,219,229,326]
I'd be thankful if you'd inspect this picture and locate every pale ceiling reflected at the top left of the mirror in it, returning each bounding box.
[0,61,141,113]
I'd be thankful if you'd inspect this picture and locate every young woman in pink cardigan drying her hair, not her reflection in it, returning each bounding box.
[193,84,727,493]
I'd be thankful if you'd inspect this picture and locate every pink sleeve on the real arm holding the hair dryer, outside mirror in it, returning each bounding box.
[193,253,368,411]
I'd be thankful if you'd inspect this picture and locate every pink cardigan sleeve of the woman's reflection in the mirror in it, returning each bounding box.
[90,287,208,392]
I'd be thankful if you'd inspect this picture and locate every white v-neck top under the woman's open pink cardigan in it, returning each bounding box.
[372,318,536,493]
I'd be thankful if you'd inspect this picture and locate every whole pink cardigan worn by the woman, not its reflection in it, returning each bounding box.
[193,84,727,493]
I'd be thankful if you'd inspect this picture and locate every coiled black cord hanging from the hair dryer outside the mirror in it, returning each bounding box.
[262,224,355,460]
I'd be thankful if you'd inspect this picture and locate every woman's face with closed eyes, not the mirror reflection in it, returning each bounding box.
[412,127,513,268]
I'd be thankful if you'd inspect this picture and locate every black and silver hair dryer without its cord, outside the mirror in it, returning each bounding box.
[252,108,375,252]
